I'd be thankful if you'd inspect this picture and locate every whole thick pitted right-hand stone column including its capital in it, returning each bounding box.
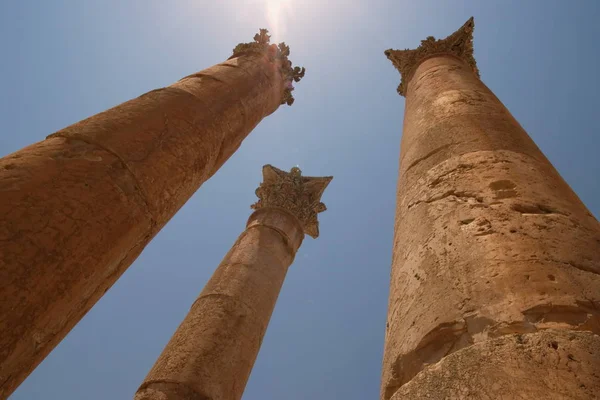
[381,19,600,400]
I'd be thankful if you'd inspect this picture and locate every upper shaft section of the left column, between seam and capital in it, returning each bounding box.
[52,55,283,225]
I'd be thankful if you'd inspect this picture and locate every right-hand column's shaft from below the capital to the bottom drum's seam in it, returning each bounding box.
[381,20,600,400]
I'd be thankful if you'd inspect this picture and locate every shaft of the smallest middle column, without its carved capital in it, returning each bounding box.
[135,210,301,400]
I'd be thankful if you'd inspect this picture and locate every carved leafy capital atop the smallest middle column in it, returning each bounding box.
[251,165,333,238]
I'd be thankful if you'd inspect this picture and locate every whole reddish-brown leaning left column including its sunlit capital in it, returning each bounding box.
[0,30,304,398]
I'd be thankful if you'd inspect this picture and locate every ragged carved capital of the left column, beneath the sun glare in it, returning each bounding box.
[229,29,306,106]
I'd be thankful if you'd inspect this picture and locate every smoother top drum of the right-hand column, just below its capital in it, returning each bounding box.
[400,56,553,192]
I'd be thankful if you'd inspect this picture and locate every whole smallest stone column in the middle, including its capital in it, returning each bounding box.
[135,165,332,400]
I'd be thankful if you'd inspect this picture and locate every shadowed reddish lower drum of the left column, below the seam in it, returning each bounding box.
[0,138,154,399]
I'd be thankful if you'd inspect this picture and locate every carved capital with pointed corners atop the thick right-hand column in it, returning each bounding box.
[385,17,479,96]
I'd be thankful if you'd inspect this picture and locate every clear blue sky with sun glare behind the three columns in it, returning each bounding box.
[0,0,600,400]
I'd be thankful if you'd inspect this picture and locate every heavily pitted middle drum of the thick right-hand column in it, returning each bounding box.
[386,151,600,396]
